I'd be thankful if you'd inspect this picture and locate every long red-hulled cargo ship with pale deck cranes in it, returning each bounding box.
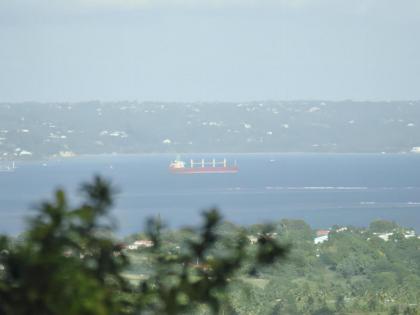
[169,158,239,174]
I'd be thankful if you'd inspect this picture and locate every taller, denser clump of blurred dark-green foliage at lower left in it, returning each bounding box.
[0,178,128,314]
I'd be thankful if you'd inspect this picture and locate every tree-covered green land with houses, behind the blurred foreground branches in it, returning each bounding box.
[129,220,420,315]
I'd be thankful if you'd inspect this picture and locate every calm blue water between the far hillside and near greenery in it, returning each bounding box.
[0,154,420,234]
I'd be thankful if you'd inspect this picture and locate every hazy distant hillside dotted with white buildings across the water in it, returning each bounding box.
[0,101,420,160]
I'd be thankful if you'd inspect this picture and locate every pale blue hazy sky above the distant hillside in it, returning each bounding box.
[0,0,420,101]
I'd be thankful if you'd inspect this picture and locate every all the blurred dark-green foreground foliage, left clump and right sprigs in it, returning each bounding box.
[0,177,288,315]
